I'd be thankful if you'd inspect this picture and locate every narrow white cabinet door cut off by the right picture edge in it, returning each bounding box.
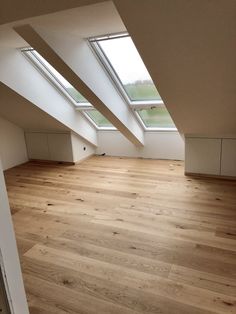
[221,139,236,177]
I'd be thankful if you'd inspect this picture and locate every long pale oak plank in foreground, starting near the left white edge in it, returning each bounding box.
[25,245,236,313]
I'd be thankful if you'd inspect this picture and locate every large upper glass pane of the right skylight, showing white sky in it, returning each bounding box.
[97,36,161,101]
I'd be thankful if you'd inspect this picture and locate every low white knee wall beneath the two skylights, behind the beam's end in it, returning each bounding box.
[96,131,184,160]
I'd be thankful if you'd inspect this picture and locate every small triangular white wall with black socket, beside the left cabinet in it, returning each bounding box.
[71,133,96,162]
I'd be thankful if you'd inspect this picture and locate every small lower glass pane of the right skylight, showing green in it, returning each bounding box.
[137,105,175,128]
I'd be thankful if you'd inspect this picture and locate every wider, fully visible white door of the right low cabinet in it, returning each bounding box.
[185,137,221,175]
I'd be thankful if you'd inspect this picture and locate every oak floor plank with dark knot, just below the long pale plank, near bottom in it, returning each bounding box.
[23,258,216,314]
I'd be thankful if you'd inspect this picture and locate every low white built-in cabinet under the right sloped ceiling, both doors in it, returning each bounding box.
[185,137,236,177]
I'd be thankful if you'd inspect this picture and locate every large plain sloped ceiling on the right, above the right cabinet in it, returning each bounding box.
[114,0,236,136]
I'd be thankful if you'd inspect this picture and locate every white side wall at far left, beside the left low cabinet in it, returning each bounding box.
[0,117,28,170]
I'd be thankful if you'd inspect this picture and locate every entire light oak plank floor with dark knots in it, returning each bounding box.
[3,157,236,314]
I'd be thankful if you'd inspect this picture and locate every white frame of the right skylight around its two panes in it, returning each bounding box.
[87,32,177,132]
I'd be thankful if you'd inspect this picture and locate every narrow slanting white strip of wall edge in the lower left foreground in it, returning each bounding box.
[0,162,29,314]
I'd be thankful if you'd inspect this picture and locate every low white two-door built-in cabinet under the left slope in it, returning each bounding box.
[25,132,73,162]
